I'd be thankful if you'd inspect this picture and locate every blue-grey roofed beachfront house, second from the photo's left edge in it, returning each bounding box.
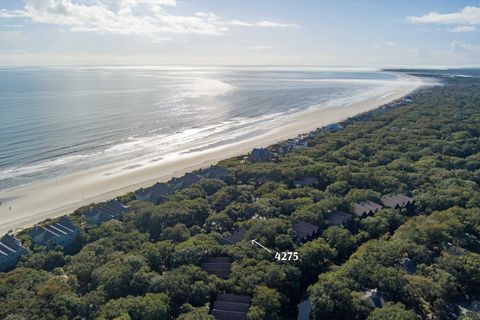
[28,216,80,249]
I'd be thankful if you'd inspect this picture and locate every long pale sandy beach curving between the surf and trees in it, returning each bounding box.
[0,76,425,233]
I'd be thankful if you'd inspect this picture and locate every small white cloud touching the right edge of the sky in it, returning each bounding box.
[407,7,480,26]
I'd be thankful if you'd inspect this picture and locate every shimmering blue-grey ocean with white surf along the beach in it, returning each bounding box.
[0,66,405,191]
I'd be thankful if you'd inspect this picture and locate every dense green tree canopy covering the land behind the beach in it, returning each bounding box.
[0,77,480,320]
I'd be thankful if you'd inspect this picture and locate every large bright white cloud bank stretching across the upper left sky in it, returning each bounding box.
[0,0,297,42]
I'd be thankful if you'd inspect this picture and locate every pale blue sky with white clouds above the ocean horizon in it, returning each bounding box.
[0,0,480,67]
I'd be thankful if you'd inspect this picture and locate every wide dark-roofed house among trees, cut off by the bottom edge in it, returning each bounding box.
[212,293,252,320]
